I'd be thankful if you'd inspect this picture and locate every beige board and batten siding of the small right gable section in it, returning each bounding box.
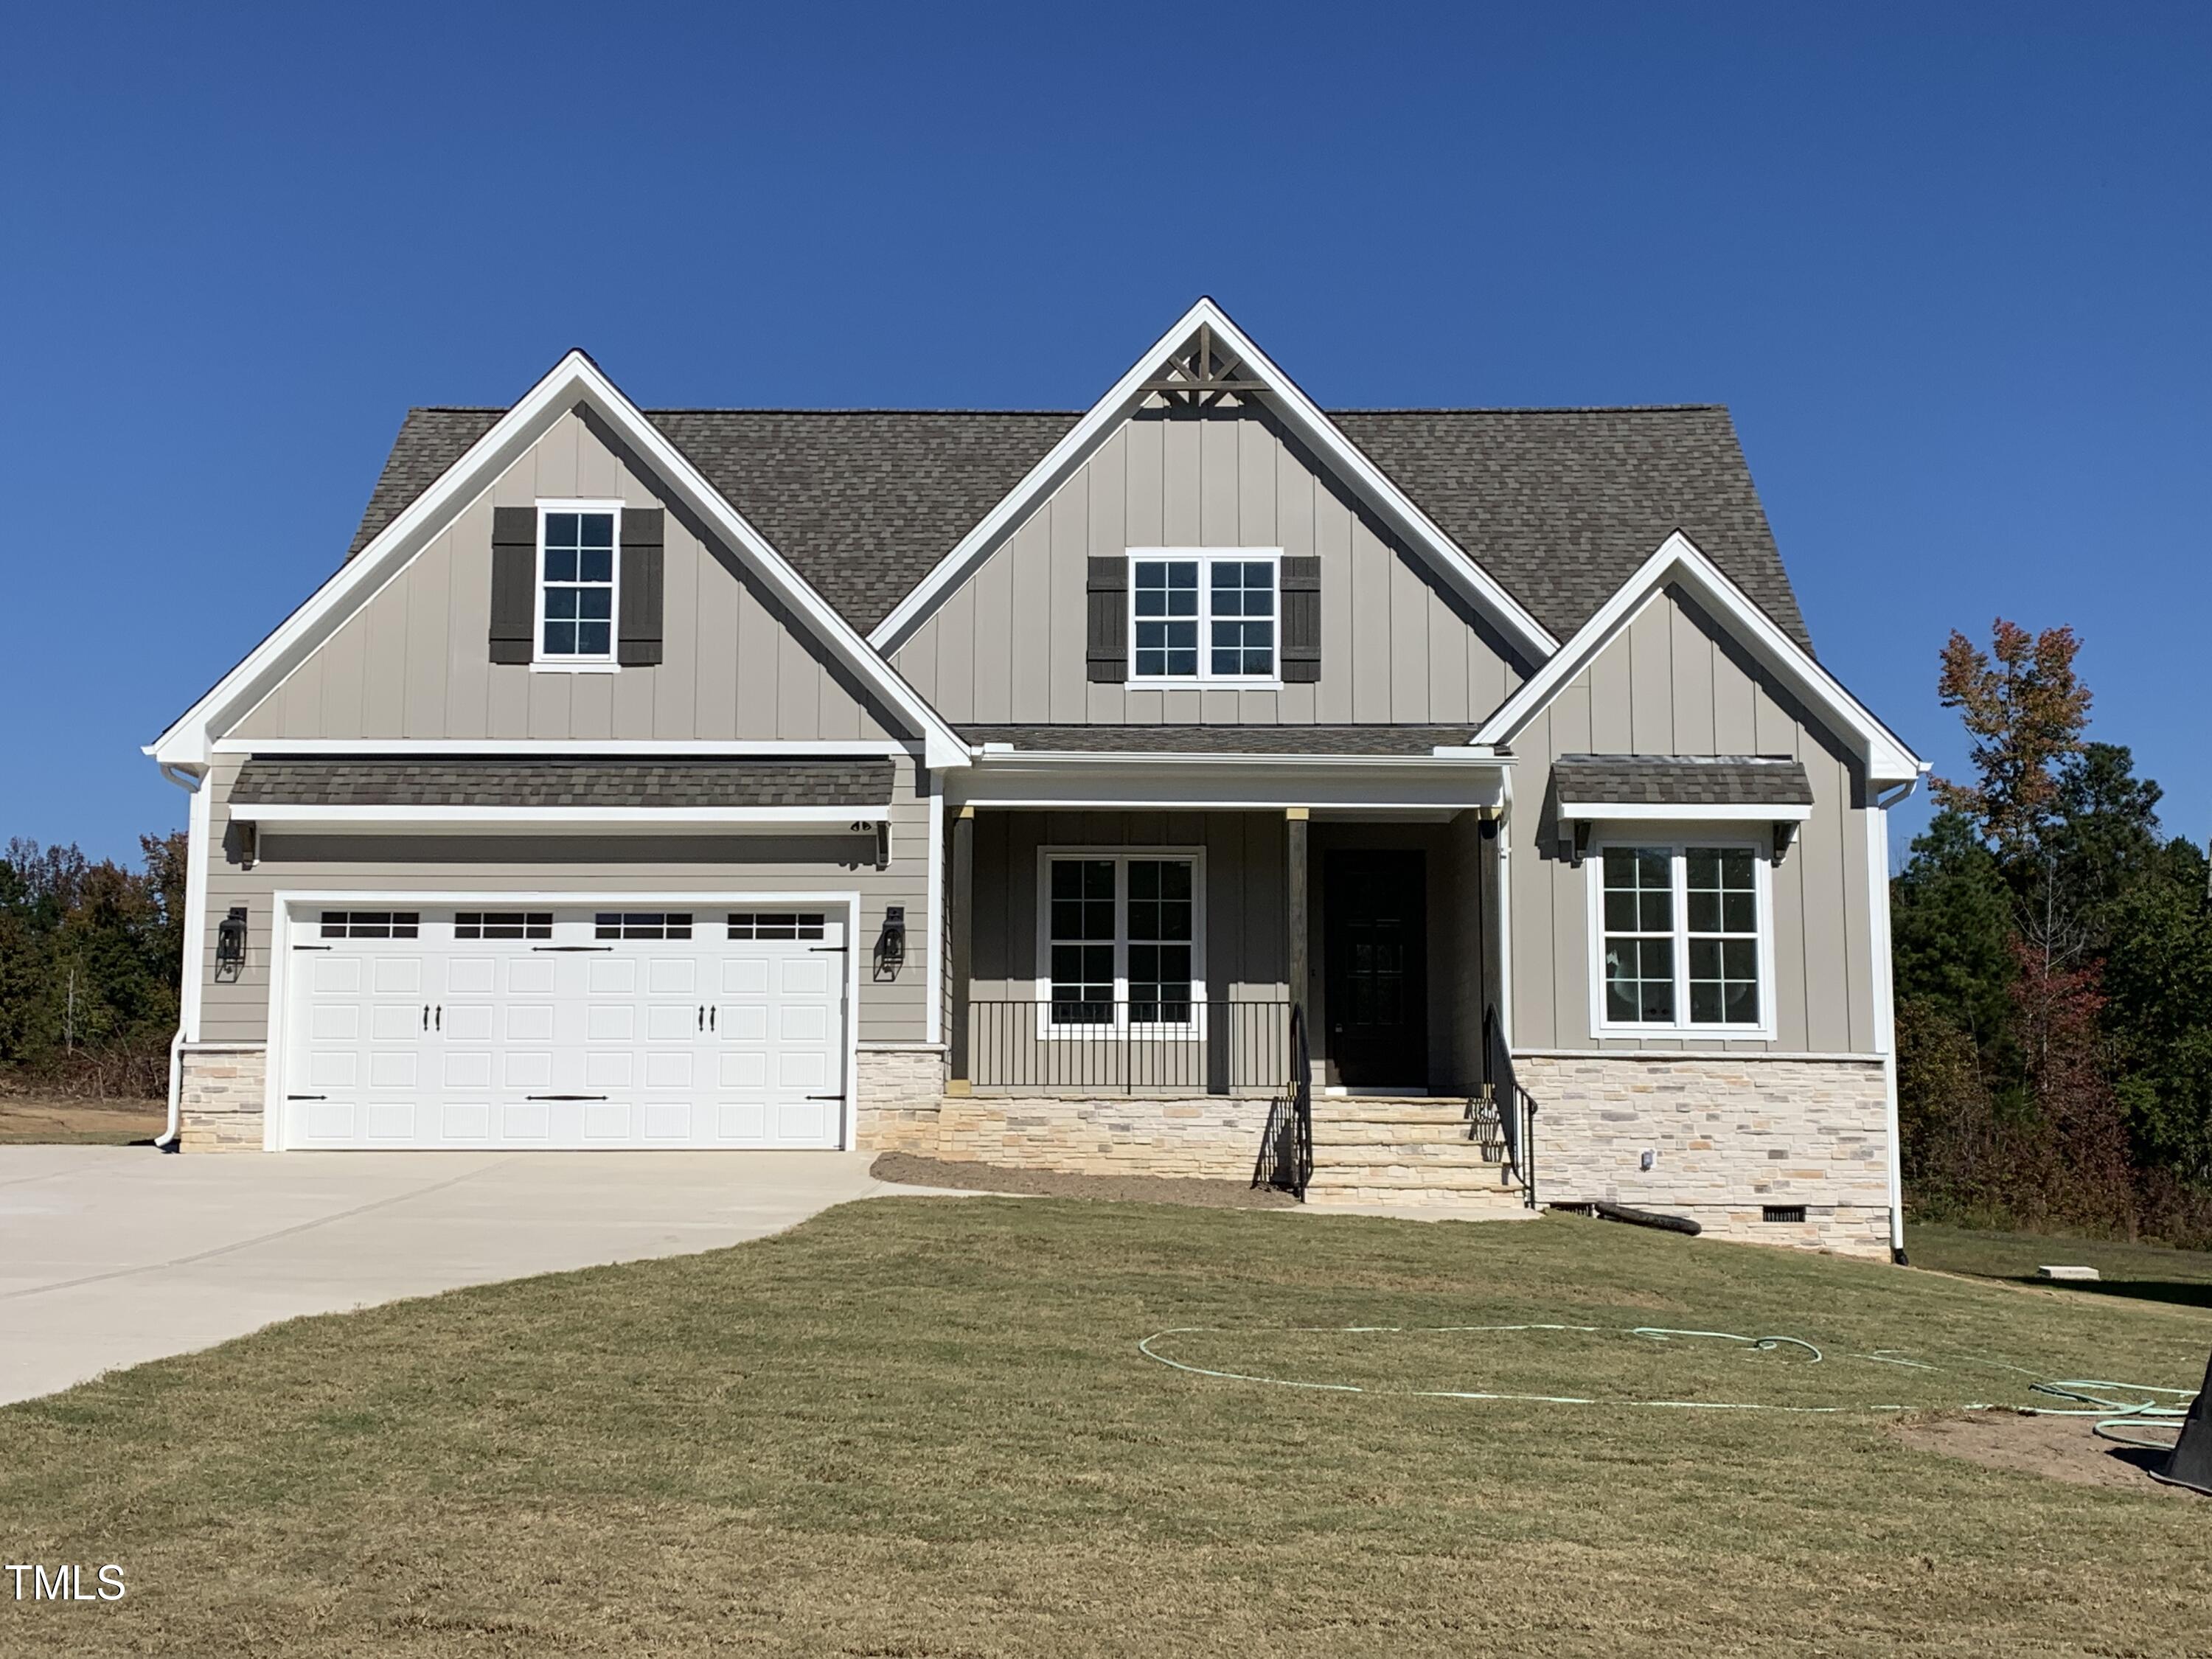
[1511,591,1876,1055]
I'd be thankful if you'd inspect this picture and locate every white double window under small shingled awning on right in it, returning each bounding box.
[1588,838,1774,1037]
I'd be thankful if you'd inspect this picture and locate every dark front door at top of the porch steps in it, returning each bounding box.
[1321,852,1429,1088]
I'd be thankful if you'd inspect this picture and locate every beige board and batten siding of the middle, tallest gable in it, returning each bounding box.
[891,411,1522,726]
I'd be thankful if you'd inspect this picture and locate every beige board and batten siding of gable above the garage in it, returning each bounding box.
[226,411,896,741]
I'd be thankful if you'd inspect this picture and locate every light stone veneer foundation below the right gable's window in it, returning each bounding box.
[1513,1053,1889,1259]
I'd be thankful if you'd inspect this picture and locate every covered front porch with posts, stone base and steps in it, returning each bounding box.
[925,730,1513,1197]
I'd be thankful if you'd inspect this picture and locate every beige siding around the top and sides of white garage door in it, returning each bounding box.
[199,754,931,1044]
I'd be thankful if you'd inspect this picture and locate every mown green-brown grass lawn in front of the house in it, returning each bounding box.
[0,1199,2212,1655]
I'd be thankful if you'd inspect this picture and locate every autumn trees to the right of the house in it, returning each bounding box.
[1891,619,2212,1243]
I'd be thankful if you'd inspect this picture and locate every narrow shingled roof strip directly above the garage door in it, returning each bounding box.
[230,757,891,807]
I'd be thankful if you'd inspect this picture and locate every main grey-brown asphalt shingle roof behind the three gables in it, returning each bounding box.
[347,405,1812,648]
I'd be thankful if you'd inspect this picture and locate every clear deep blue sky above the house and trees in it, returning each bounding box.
[0,4,2212,872]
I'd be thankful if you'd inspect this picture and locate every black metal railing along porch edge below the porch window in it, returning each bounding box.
[967,998,1303,1095]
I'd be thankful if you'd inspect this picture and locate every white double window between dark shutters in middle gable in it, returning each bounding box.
[1128,549,1283,684]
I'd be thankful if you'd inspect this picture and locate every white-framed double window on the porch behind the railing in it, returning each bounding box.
[1037,849,1206,1031]
